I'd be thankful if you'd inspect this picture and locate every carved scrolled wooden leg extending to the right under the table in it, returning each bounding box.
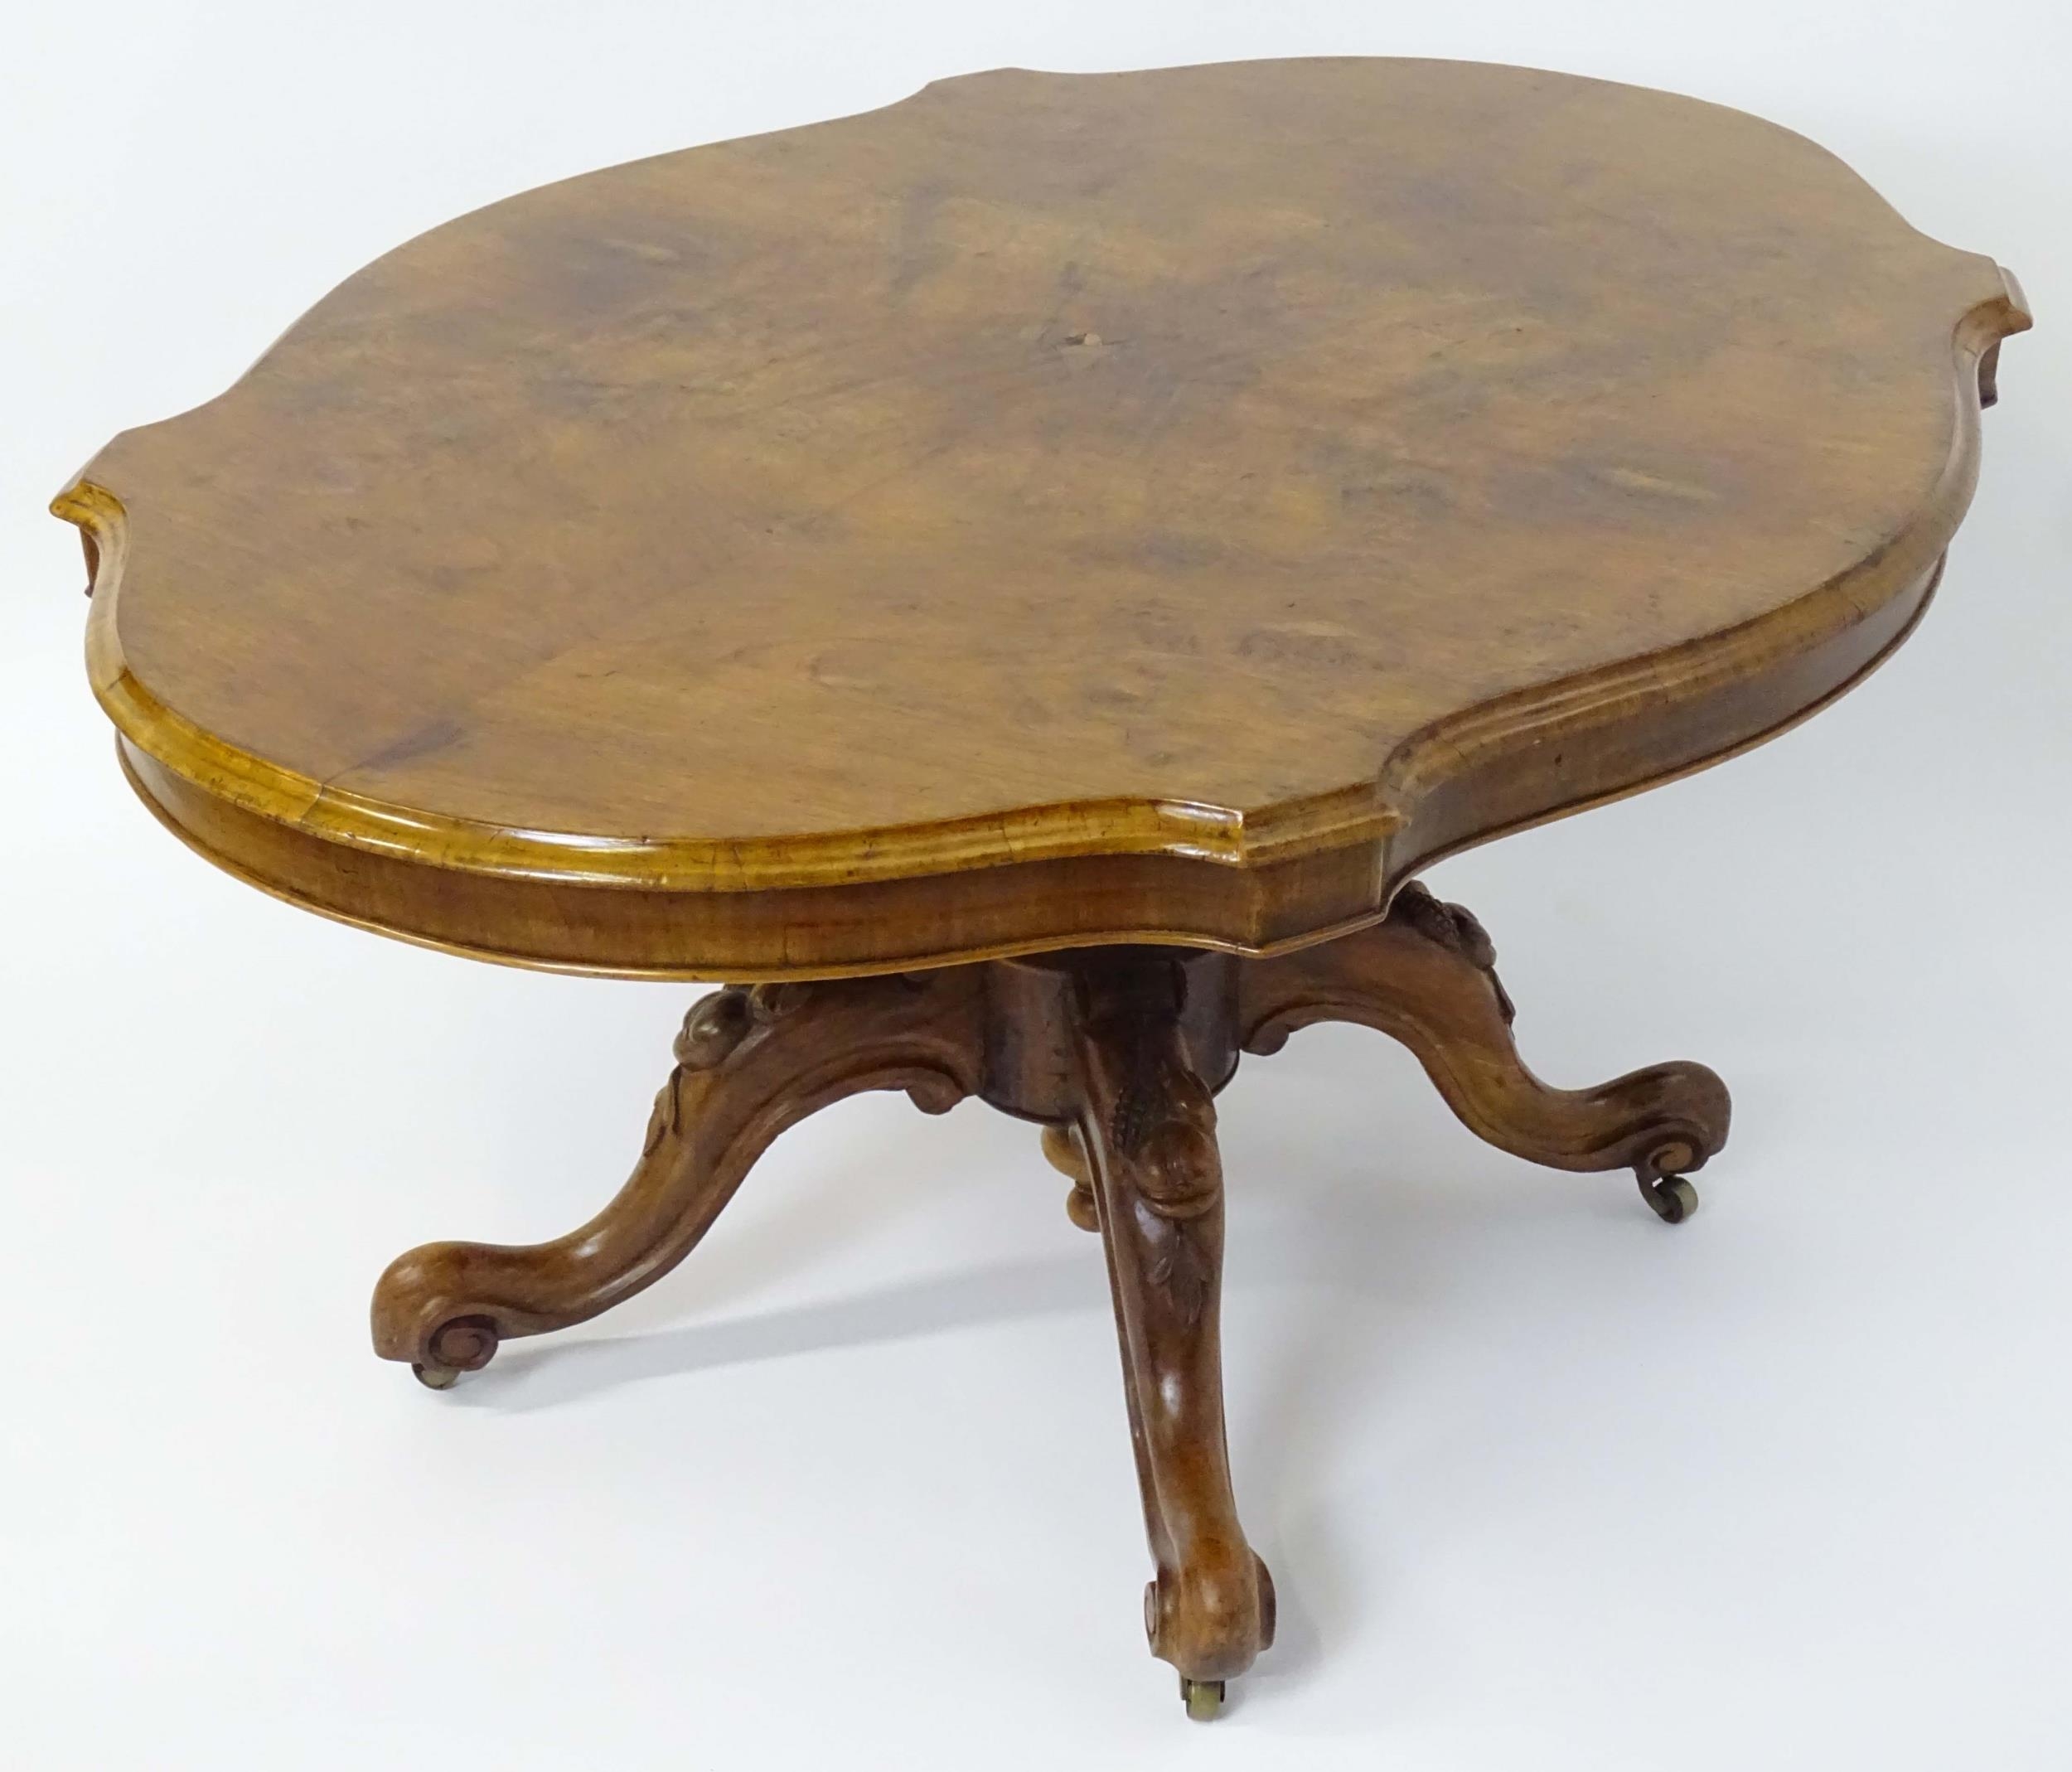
[1239,881,1728,1225]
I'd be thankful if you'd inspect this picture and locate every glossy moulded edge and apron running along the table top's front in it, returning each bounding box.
[52,272,2031,978]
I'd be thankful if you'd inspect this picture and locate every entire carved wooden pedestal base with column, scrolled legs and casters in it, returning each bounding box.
[373,885,1728,1716]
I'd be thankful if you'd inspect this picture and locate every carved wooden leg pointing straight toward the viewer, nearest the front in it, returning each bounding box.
[1048,953,1275,1716]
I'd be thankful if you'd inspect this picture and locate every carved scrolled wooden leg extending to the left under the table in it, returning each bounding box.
[373,968,980,1388]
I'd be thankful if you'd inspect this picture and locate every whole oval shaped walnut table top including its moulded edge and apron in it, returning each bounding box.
[56,61,2029,978]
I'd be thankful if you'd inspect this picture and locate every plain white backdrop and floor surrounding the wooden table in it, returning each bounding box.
[0,0,2072,1772]
